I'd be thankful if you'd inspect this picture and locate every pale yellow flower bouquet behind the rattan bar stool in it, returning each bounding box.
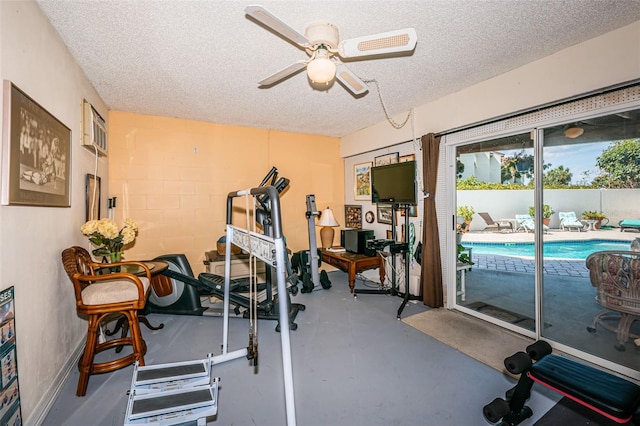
[80,218,138,262]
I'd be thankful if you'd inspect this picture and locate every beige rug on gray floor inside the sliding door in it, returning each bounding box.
[402,308,533,375]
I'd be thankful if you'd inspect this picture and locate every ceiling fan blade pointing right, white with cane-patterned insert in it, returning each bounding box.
[338,28,418,58]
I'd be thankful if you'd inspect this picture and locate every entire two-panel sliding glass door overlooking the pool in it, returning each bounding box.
[448,99,640,378]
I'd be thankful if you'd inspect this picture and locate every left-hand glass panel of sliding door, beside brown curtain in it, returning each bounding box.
[455,132,535,333]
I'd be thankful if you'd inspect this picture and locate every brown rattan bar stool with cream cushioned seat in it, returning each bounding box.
[62,246,151,396]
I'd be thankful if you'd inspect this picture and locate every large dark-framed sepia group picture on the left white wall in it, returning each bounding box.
[1,80,71,207]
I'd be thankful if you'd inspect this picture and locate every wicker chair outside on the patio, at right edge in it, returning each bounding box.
[586,251,640,351]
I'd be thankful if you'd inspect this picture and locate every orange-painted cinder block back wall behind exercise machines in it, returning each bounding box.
[109,111,344,273]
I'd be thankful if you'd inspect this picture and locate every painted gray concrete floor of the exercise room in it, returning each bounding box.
[43,271,559,426]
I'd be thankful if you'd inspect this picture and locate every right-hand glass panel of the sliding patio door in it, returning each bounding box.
[540,110,640,370]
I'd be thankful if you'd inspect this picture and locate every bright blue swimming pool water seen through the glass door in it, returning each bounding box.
[462,240,630,259]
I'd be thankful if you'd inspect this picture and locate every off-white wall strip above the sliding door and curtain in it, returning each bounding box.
[341,21,640,157]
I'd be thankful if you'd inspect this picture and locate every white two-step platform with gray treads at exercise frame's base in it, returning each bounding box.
[124,355,220,426]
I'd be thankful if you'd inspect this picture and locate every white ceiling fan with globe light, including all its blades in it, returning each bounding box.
[245,5,418,95]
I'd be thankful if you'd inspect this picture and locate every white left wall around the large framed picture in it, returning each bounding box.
[0,1,108,424]
